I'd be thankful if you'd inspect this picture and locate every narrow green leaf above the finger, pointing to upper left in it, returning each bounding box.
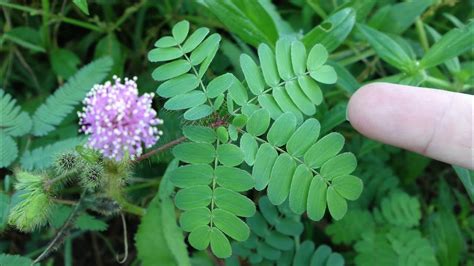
[357,24,416,72]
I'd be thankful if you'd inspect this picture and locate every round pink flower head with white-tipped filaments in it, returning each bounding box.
[78,76,163,161]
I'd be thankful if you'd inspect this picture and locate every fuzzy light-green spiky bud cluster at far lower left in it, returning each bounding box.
[8,172,52,232]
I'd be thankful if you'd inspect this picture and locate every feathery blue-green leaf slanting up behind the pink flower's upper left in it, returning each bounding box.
[33,57,113,136]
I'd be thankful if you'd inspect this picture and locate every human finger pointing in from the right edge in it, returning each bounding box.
[347,83,474,169]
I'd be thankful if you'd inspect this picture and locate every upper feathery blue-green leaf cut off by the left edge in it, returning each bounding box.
[0,89,32,137]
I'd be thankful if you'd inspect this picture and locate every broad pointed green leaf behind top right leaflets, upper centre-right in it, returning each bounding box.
[302,8,356,52]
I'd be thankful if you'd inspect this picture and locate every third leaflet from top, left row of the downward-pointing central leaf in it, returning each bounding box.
[170,164,214,188]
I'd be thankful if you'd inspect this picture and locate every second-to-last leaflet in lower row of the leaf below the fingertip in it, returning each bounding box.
[306,176,328,221]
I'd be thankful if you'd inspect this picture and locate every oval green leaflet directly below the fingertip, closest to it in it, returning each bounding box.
[304,132,344,168]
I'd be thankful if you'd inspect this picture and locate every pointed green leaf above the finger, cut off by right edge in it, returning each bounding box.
[420,22,474,68]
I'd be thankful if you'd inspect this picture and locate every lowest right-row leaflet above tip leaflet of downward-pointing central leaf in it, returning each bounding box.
[212,209,250,241]
